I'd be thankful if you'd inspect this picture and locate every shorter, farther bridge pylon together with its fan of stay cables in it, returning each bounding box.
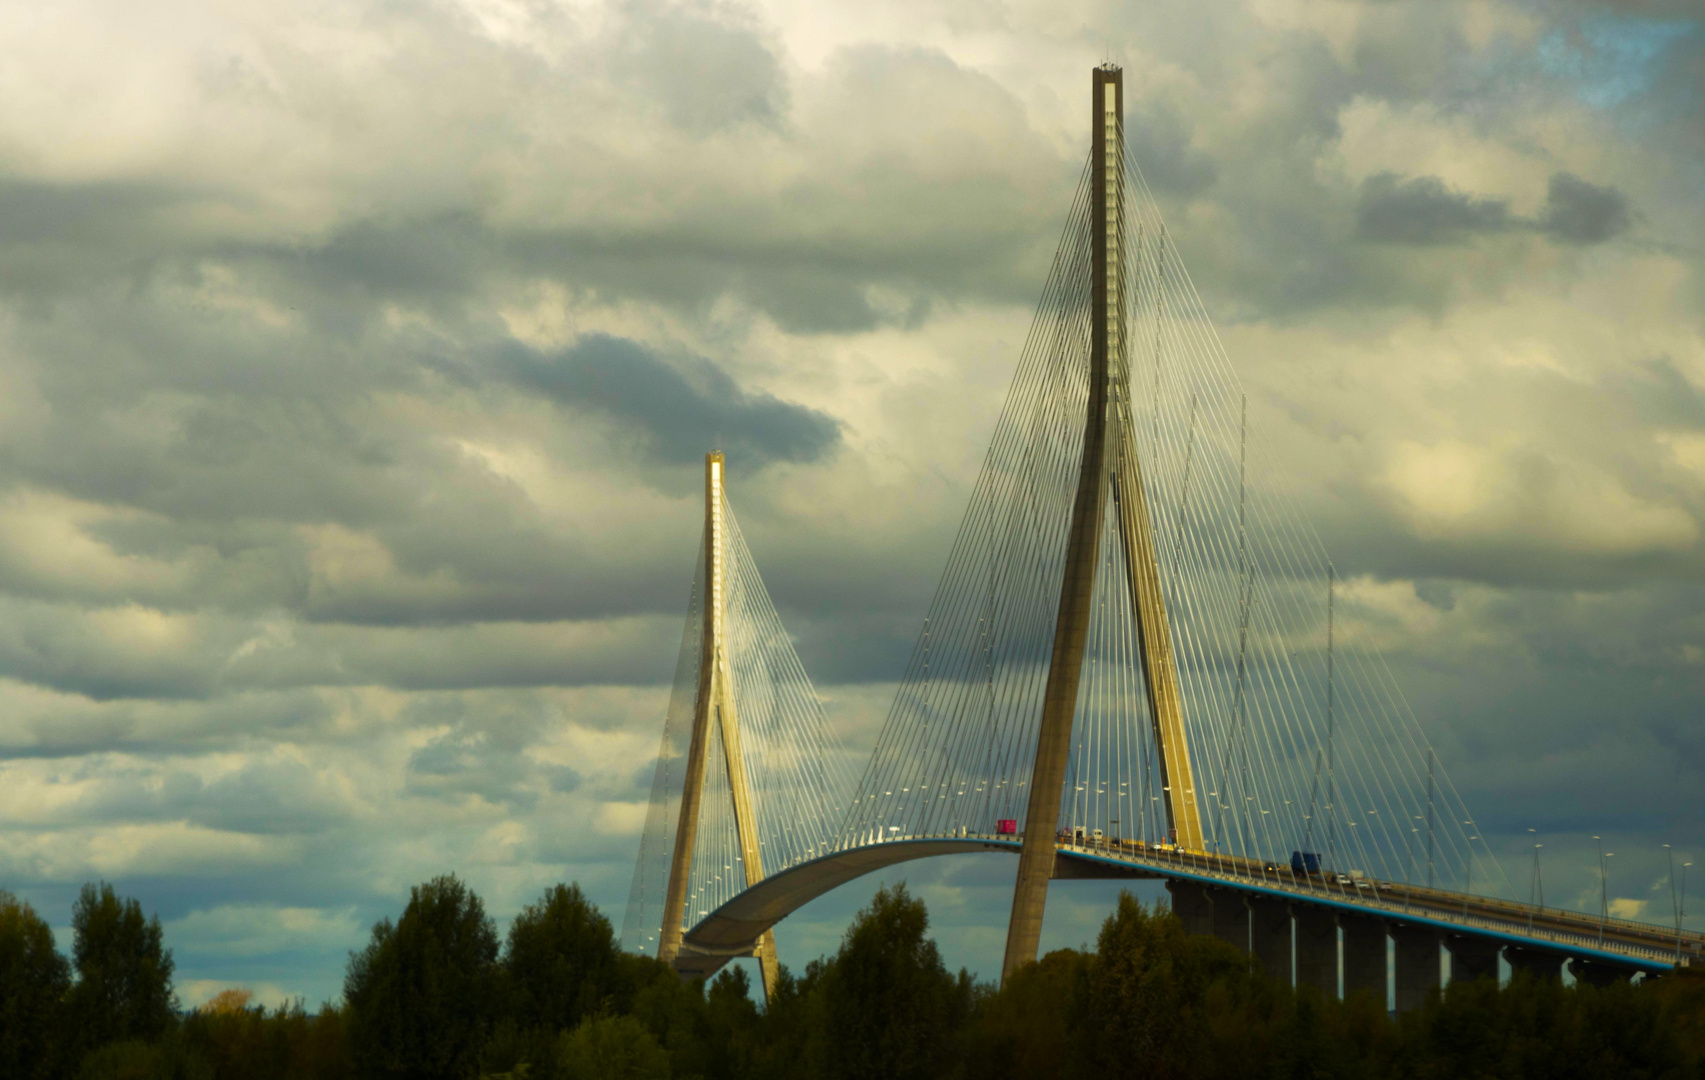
[622,452,847,996]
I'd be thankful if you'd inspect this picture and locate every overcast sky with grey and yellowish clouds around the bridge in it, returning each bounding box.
[0,0,1705,1007]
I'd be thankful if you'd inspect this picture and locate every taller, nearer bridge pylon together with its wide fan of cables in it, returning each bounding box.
[844,65,1507,976]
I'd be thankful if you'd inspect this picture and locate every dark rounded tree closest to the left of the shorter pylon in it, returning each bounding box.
[503,885,619,1032]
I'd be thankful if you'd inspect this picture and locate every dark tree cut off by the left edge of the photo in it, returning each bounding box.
[0,891,72,1080]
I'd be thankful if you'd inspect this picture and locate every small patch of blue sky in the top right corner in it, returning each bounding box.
[1538,15,1700,109]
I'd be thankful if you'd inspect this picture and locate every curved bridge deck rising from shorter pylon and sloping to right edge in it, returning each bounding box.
[675,834,1705,978]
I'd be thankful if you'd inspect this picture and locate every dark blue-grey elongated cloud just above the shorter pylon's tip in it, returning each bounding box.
[501,334,841,467]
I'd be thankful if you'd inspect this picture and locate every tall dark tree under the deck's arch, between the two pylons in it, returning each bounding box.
[822,884,970,1080]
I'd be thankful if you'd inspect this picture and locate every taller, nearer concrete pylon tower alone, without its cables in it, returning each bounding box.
[1001,63,1202,979]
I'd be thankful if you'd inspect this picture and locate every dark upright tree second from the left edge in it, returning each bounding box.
[68,882,177,1049]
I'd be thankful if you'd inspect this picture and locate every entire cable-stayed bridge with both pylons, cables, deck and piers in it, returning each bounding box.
[622,65,1705,1008]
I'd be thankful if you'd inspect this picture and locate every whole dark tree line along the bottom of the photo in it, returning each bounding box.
[0,875,1705,1080]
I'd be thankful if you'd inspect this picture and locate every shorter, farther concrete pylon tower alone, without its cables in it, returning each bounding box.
[656,452,779,1000]
